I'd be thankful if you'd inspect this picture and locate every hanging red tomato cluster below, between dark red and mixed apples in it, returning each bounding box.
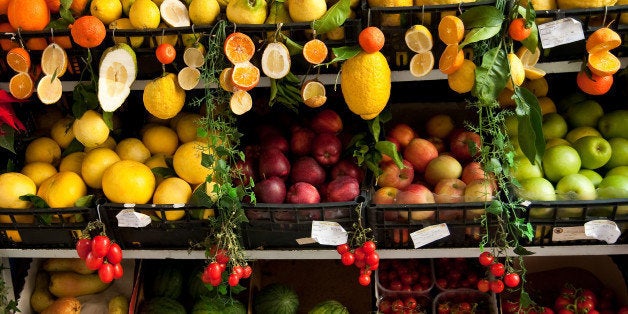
[336,241,379,286]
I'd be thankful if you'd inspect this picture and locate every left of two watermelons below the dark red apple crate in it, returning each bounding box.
[253,283,299,314]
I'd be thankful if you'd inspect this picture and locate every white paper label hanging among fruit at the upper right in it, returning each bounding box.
[538,17,584,49]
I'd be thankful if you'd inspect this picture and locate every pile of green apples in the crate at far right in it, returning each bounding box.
[506,94,628,218]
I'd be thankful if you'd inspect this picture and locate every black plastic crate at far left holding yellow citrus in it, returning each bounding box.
[0,207,96,249]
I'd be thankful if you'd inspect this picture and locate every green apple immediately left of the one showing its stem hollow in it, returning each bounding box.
[542,145,581,182]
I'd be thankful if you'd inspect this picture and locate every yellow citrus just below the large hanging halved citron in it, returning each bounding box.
[72,110,109,147]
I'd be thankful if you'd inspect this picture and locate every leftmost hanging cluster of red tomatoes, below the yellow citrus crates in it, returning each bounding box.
[76,234,124,283]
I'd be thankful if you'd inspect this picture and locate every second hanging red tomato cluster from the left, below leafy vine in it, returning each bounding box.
[201,249,253,287]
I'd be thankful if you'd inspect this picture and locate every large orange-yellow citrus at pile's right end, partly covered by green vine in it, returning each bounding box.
[172,141,213,184]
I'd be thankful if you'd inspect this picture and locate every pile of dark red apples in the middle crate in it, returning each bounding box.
[236,109,364,204]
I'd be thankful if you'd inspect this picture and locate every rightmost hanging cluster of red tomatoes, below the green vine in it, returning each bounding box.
[477,251,521,293]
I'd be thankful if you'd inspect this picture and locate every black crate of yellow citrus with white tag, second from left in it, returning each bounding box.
[98,203,213,249]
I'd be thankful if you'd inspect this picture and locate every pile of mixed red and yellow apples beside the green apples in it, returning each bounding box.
[373,114,495,221]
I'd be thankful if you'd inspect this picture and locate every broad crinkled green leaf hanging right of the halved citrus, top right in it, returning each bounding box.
[473,47,510,104]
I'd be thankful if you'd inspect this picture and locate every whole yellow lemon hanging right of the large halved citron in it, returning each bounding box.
[145,73,185,119]
